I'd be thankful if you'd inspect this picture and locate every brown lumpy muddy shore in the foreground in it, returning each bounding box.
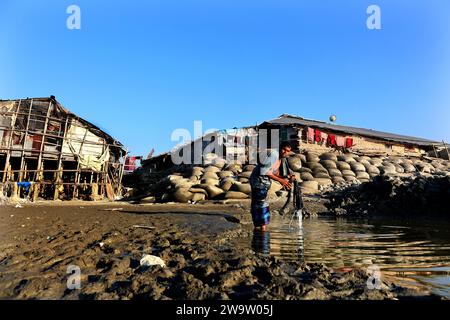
[0,201,440,300]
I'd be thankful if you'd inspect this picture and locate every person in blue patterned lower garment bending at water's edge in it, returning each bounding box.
[250,142,292,232]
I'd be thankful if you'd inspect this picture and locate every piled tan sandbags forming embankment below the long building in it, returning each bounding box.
[149,152,450,203]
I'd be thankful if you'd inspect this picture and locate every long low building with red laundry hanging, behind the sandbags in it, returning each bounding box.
[143,114,447,171]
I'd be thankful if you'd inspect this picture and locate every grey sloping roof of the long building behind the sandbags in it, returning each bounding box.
[261,114,442,147]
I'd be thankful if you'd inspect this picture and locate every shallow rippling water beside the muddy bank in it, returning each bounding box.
[252,215,450,297]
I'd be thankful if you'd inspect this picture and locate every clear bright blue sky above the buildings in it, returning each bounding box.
[0,0,450,155]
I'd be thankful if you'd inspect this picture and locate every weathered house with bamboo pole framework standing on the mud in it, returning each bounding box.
[0,96,126,200]
